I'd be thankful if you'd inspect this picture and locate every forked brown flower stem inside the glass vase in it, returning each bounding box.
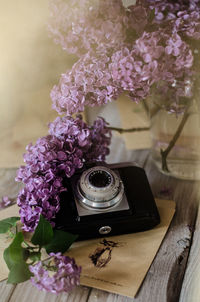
[160,108,190,172]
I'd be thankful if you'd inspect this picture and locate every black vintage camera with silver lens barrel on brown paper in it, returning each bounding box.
[55,162,160,240]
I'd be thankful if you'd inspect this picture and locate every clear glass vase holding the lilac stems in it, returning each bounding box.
[151,100,200,180]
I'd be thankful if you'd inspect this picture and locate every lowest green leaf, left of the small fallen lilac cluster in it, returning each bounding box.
[7,261,32,283]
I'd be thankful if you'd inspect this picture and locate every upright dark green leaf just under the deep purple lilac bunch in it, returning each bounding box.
[31,215,53,247]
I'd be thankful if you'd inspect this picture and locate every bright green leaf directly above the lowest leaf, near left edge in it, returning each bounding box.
[3,232,25,269]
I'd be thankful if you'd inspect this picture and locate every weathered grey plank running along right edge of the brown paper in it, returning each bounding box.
[135,159,199,302]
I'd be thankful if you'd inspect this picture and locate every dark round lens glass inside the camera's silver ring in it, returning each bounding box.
[89,170,112,188]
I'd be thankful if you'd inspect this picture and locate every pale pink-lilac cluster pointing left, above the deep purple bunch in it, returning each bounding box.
[51,52,120,115]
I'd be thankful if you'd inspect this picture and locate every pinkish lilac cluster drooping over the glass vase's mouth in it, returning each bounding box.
[135,31,193,114]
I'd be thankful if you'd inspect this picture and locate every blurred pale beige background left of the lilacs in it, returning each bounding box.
[0,0,73,167]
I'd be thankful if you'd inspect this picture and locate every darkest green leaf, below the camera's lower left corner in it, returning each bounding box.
[44,230,78,254]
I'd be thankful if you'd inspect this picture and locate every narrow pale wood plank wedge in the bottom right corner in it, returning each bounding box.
[180,193,200,302]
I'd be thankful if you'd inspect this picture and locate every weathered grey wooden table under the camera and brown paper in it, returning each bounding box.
[0,147,200,302]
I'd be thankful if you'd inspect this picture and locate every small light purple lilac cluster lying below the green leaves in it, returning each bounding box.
[29,253,81,294]
